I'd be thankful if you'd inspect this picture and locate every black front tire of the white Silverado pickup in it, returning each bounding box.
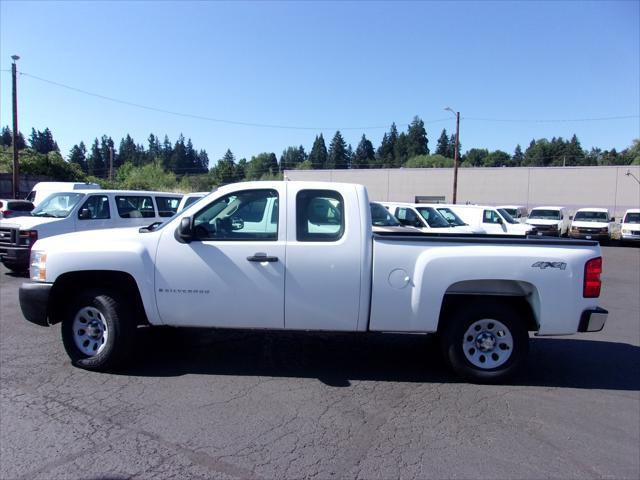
[61,290,136,371]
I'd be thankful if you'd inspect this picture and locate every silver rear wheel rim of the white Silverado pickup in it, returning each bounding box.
[462,318,513,370]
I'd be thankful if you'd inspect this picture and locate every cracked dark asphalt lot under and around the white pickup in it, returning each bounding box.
[0,247,640,480]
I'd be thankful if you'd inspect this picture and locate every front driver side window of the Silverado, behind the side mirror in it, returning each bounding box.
[193,189,278,241]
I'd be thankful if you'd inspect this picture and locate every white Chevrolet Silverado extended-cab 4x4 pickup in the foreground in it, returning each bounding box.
[20,182,607,382]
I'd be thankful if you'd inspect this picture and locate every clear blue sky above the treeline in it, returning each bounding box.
[0,1,640,165]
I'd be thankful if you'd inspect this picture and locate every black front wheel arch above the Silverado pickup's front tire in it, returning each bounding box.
[48,270,149,325]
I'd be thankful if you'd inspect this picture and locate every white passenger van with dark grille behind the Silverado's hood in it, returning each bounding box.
[0,189,182,271]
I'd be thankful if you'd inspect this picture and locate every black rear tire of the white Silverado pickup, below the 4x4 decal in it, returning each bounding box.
[440,299,529,383]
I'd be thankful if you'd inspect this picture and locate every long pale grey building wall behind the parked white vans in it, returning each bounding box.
[285,165,640,217]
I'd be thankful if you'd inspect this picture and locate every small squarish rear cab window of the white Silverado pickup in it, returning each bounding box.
[296,190,345,242]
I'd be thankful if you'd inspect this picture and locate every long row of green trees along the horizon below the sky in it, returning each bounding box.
[0,116,640,189]
